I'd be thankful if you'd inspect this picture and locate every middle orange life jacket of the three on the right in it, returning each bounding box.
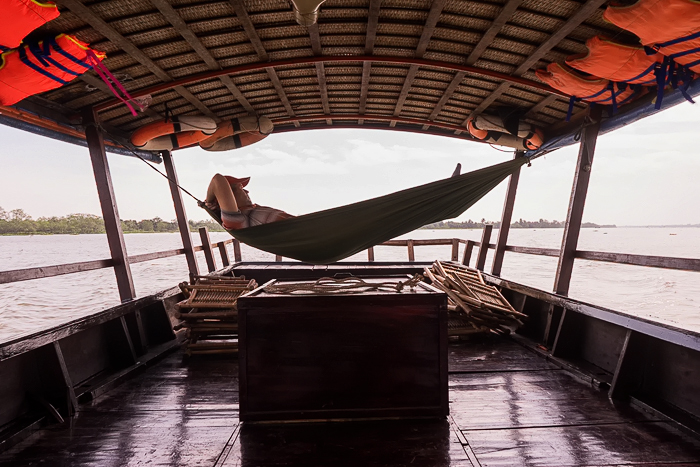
[566,36,663,85]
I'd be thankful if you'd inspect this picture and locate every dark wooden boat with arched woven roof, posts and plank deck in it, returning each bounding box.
[0,0,700,467]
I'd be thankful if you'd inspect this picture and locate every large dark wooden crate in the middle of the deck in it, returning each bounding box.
[238,276,448,421]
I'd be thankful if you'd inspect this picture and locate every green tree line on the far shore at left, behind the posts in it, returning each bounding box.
[0,207,224,235]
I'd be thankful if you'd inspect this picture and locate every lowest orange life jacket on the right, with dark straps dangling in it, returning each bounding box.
[535,62,641,121]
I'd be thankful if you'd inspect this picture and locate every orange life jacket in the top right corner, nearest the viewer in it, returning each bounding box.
[603,0,700,73]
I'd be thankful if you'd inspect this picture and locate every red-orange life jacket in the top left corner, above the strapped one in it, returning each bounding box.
[0,0,59,49]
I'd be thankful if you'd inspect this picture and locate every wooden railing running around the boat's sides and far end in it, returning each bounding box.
[0,228,700,284]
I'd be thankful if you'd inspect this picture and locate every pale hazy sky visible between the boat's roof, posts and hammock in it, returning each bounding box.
[0,103,700,225]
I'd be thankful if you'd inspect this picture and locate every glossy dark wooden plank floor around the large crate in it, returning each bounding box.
[0,338,700,467]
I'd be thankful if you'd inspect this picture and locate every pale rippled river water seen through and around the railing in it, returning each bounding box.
[0,228,700,342]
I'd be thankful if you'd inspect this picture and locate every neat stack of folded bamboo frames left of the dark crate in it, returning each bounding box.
[177,276,257,355]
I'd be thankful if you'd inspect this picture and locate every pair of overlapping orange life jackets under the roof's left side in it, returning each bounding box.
[0,0,105,105]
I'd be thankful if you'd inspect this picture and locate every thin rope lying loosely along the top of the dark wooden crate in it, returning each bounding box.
[263,274,423,294]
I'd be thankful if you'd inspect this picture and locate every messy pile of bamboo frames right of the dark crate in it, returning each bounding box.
[425,261,527,336]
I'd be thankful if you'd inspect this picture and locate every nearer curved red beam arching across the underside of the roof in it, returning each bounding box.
[96,55,568,111]
